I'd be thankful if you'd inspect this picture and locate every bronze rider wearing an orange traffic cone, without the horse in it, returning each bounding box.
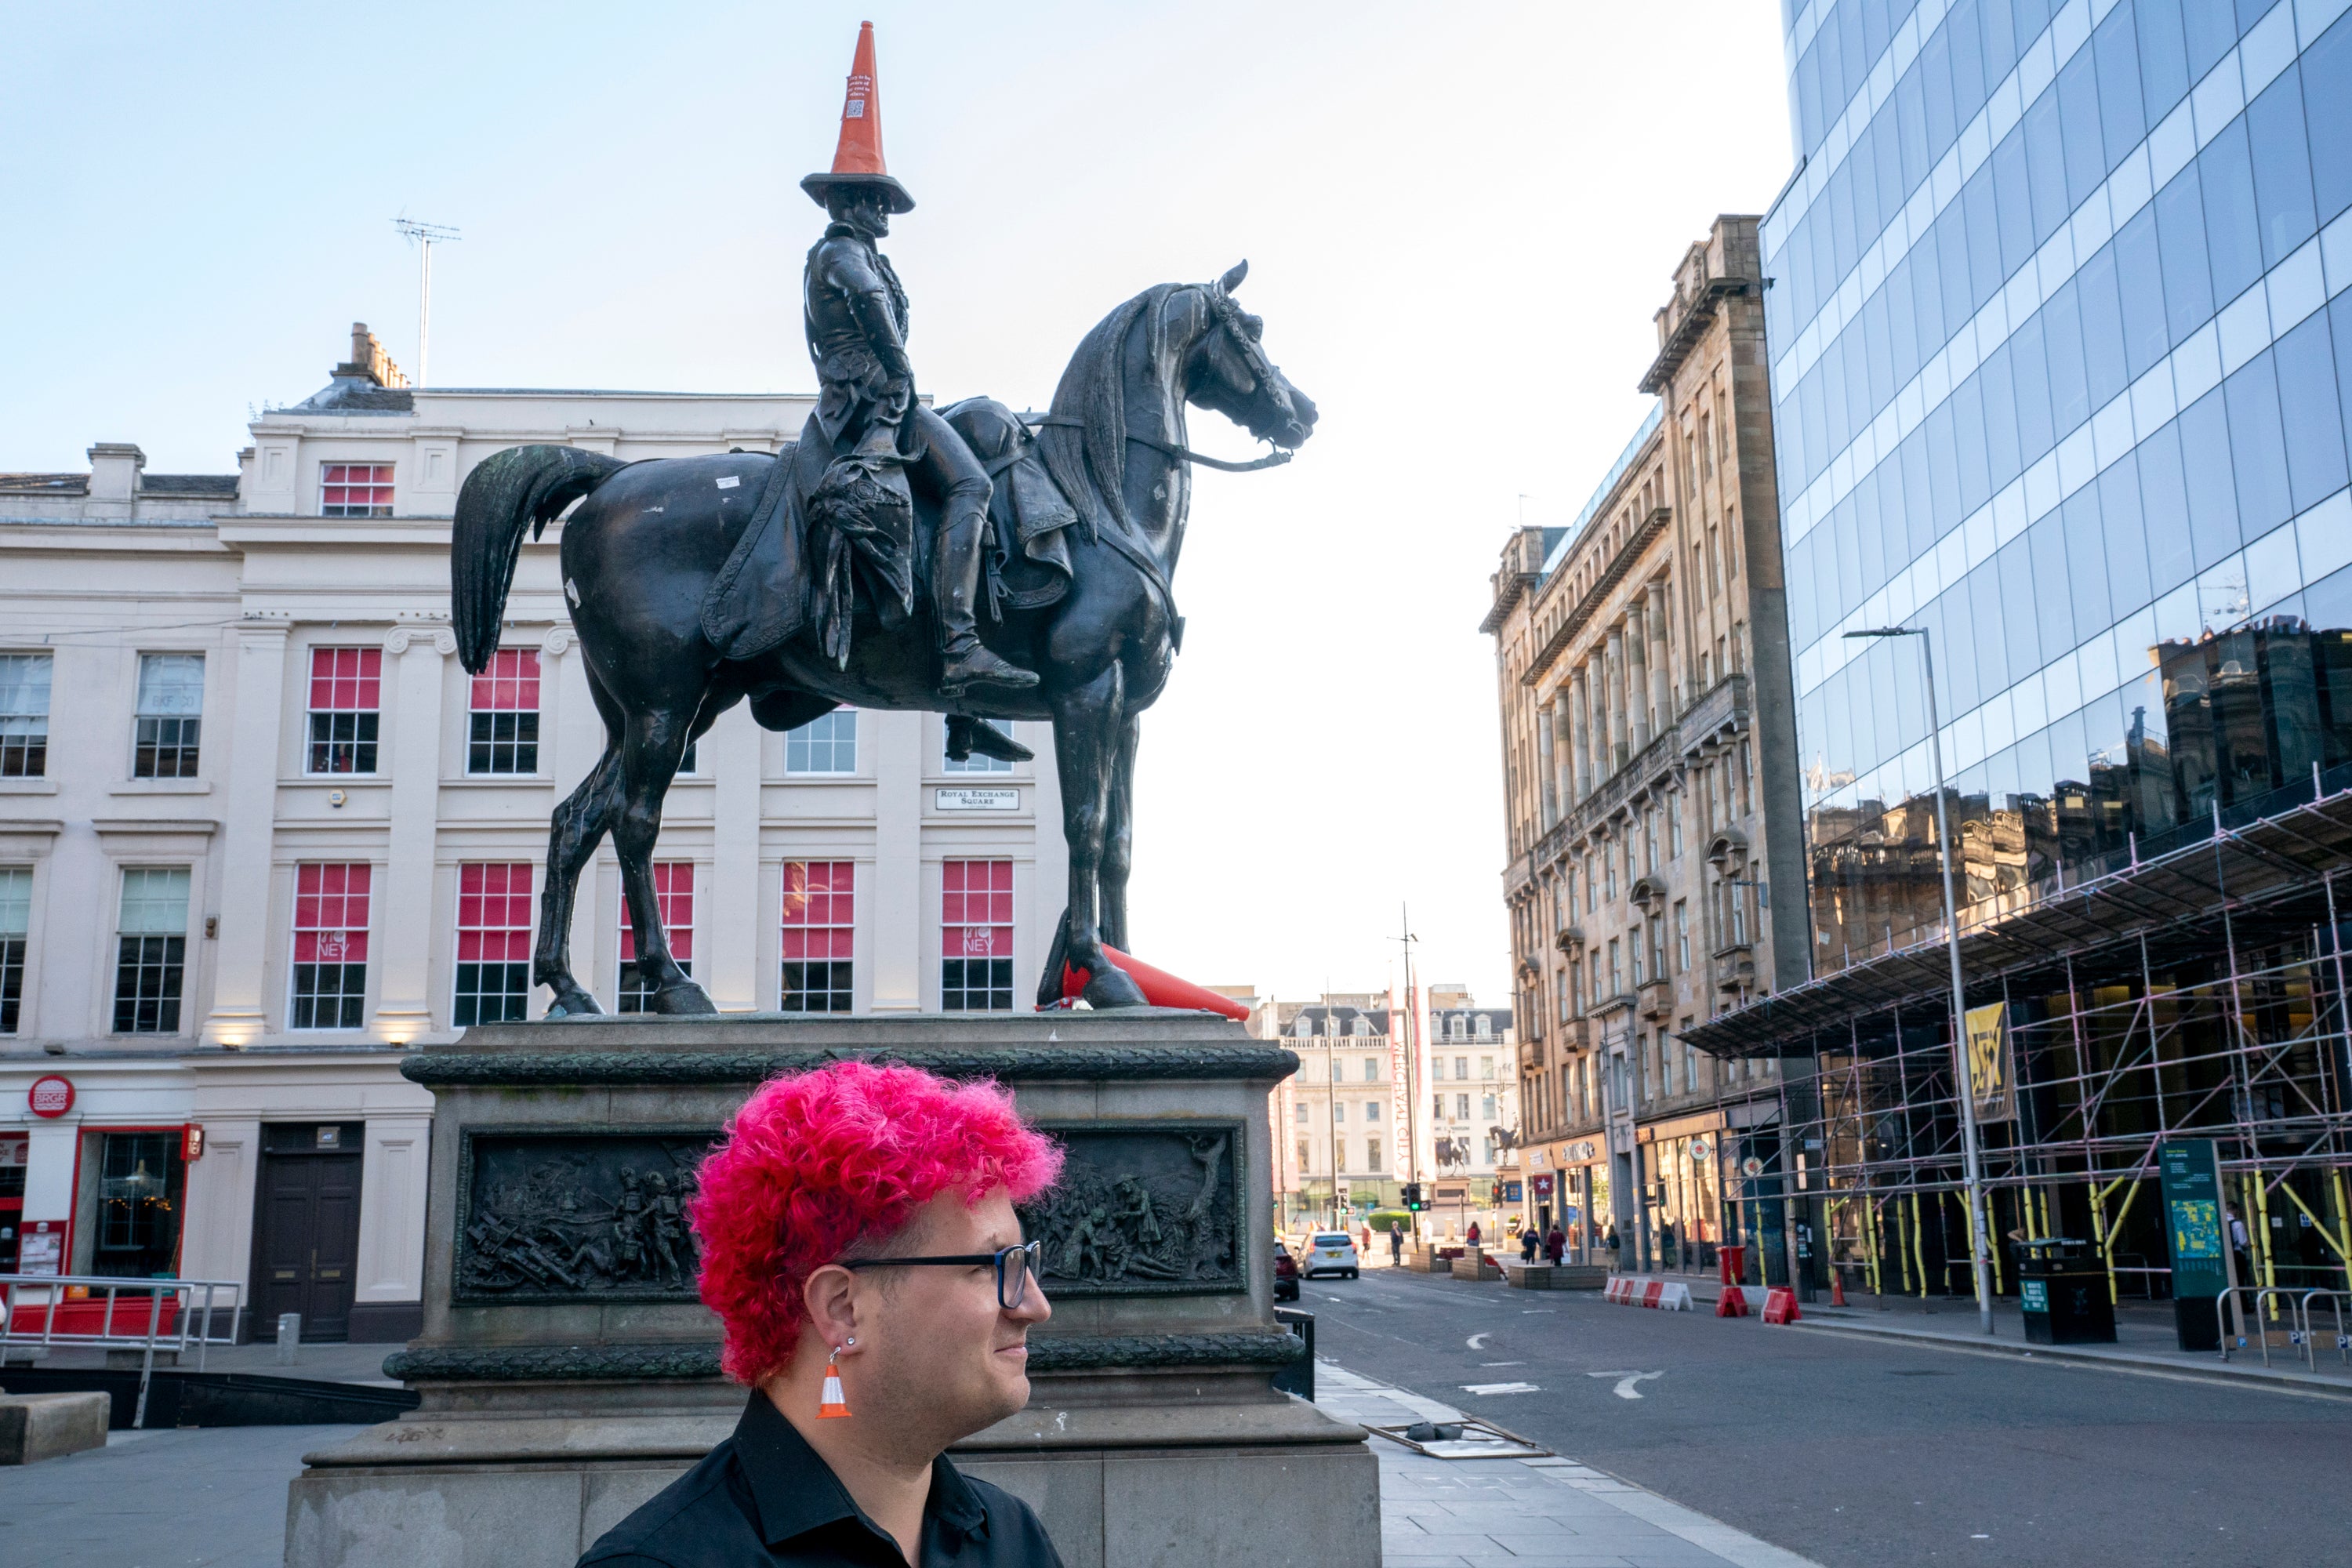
[800,24,1037,700]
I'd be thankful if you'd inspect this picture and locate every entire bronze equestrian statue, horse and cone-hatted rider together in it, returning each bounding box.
[449,36,1315,1018]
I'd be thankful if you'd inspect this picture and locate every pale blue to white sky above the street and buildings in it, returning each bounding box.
[0,0,1792,1001]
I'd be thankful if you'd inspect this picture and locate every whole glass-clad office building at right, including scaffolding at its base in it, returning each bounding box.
[1703,0,2352,1293]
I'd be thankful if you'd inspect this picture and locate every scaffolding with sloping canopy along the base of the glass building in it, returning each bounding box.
[1693,769,2352,1316]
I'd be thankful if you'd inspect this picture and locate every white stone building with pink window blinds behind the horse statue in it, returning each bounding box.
[0,329,1065,1340]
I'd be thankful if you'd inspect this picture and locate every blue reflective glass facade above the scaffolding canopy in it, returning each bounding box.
[1762,0,2352,975]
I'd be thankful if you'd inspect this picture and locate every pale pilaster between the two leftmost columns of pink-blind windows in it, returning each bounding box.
[369,626,456,1044]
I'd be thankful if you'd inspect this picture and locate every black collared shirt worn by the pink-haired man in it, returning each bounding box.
[579,1389,1061,1568]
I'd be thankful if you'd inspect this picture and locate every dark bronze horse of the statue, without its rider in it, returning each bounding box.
[449,261,1315,1018]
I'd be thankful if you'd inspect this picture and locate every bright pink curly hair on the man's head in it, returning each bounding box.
[687,1062,1061,1385]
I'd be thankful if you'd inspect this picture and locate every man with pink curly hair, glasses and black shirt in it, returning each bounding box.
[581,1062,1061,1568]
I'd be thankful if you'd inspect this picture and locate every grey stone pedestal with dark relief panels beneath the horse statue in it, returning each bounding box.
[287,1008,1381,1568]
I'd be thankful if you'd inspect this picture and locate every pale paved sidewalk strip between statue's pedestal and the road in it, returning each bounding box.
[1315,1361,1816,1568]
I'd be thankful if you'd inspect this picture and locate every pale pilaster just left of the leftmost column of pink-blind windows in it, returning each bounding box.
[203,621,292,1048]
